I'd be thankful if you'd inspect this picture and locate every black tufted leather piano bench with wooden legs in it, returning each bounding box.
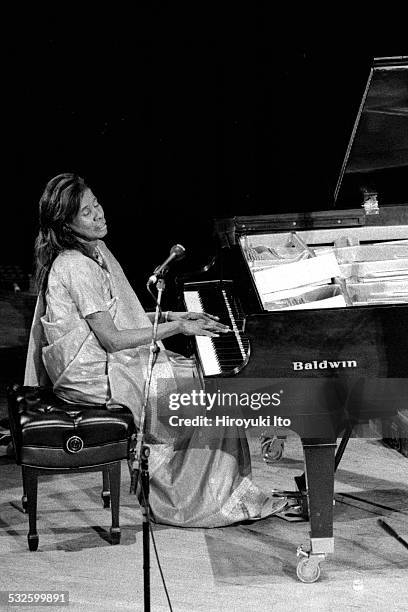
[7,385,135,551]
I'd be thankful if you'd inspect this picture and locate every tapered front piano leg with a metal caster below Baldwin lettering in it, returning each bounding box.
[297,439,336,582]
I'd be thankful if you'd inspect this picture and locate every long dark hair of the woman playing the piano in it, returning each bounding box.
[34,173,88,293]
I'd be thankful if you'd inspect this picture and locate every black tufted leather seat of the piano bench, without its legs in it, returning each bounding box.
[9,386,134,469]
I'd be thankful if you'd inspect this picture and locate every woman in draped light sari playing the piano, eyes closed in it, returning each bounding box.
[25,174,286,527]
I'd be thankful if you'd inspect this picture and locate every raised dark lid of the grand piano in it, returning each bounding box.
[334,56,408,210]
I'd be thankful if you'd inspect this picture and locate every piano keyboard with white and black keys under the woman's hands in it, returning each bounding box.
[184,283,249,376]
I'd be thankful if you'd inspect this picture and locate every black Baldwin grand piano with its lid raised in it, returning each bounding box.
[183,56,408,582]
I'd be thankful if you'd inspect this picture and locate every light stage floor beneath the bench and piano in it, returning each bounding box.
[0,434,408,612]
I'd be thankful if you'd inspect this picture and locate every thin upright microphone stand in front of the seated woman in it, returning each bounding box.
[129,270,165,612]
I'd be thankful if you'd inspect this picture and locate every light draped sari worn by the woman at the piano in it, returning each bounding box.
[25,241,276,527]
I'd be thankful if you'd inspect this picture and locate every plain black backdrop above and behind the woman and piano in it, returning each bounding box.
[0,7,407,307]
